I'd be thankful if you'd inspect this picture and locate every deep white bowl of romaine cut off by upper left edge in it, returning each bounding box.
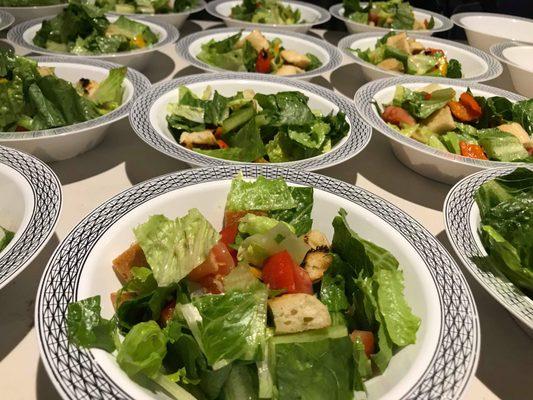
[0,57,150,162]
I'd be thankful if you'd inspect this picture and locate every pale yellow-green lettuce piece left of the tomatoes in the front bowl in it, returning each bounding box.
[134,208,220,286]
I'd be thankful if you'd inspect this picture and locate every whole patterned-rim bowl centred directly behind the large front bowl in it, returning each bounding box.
[130,73,371,170]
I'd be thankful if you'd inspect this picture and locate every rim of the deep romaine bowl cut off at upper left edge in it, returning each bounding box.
[0,56,151,144]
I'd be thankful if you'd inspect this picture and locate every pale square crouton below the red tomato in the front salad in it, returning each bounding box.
[268,293,331,333]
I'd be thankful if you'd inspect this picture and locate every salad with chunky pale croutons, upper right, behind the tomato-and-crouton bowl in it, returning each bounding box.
[349,31,463,78]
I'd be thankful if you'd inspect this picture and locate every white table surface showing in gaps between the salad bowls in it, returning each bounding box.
[0,21,533,400]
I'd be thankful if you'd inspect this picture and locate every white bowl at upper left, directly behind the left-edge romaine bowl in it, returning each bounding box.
[7,16,179,70]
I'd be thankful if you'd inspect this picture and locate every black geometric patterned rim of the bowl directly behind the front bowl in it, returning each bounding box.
[129,73,372,170]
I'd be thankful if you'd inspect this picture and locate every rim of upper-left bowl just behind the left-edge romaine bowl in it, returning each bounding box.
[7,14,180,58]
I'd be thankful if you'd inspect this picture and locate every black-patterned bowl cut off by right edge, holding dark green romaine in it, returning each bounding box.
[443,166,533,334]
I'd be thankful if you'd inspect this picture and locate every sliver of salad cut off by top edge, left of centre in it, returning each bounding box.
[95,0,197,14]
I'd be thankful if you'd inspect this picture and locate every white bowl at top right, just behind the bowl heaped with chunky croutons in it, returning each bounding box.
[329,3,453,35]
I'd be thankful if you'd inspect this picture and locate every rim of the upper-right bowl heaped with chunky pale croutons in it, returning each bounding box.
[337,31,503,82]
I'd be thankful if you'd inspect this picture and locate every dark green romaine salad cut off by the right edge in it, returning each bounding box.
[474,168,533,299]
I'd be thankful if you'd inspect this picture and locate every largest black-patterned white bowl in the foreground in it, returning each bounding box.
[35,165,480,400]
